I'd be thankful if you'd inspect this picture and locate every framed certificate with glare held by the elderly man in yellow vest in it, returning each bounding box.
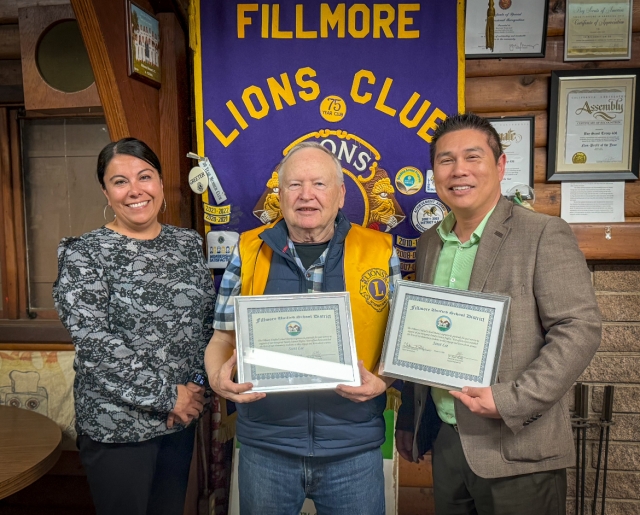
[234,292,360,392]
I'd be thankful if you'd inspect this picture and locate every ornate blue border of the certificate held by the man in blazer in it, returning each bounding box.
[392,293,496,382]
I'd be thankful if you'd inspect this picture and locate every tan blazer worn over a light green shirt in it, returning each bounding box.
[398,198,601,478]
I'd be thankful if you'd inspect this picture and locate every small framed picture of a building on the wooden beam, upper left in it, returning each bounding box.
[125,0,161,88]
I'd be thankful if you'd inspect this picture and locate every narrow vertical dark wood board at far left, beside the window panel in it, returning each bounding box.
[9,109,29,318]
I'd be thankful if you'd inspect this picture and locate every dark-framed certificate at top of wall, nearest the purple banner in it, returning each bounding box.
[464,0,549,59]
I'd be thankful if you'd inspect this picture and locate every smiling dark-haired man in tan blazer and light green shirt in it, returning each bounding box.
[396,114,601,515]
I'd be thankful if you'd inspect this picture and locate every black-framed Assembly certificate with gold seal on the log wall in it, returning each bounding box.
[547,68,640,181]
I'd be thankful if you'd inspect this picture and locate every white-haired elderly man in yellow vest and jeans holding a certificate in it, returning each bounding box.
[205,143,400,515]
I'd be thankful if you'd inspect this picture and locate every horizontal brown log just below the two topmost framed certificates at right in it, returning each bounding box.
[465,33,640,77]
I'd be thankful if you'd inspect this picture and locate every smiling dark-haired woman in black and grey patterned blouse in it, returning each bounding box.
[53,138,215,515]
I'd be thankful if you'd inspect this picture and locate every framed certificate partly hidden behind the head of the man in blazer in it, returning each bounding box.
[488,116,535,200]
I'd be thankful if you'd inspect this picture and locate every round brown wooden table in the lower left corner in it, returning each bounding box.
[0,406,62,499]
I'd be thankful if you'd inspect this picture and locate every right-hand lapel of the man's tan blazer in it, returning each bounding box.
[469,197,513,291]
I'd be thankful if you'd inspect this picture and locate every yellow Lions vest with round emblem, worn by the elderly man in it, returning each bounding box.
[238,222,393,371]
